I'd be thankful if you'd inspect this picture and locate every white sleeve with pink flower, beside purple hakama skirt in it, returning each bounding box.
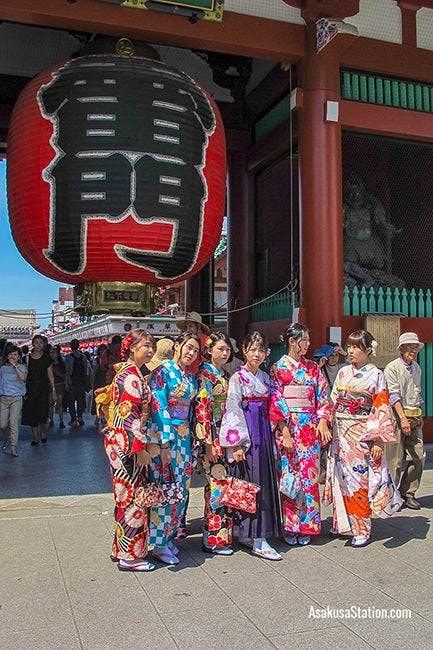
[219,372,251,451]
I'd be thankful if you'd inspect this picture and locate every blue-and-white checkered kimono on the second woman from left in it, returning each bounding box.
[147,360,197,546]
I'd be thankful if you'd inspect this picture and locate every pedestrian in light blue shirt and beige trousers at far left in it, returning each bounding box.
[0,345,27,458]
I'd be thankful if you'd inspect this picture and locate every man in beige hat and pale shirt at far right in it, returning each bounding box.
[384,332,425,510]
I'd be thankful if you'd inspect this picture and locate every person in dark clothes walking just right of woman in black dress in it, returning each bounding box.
[65,339,91,428]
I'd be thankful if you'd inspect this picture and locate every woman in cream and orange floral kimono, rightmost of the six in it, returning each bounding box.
[324,330,402,547]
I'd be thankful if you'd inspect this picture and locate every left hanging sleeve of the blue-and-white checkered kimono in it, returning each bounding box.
[147,366,175,445]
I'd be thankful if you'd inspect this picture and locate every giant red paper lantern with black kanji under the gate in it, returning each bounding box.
[7,55,226,284]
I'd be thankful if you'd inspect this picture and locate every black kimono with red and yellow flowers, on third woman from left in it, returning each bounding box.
[195,363,233,548]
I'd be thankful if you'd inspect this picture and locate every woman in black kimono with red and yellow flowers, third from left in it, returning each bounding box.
[195,332,233,555]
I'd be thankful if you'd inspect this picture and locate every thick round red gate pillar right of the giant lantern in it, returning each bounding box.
[299,21,343,347]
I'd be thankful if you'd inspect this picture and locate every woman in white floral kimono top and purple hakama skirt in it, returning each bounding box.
[219,332,281,560]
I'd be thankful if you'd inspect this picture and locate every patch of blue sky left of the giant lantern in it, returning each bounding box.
[0,160,62,326]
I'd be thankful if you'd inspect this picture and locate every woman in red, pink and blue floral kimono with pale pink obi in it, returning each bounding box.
[270,323,331,546]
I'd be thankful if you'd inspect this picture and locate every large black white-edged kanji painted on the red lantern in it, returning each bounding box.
[38,55,215,279]
